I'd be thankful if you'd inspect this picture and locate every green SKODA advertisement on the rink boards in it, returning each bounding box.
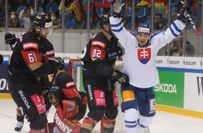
[154,71,184,108]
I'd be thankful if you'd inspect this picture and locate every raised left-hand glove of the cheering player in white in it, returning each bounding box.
[112,0,125,18]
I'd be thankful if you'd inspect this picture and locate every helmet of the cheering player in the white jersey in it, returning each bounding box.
[137,22,151,34]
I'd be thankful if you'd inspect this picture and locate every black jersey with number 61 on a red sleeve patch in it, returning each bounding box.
[8,32,54,84]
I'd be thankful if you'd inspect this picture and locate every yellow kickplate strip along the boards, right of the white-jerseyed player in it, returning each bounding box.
[156,105,203,119]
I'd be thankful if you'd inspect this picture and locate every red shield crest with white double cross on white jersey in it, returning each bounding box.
[137,48,151,64]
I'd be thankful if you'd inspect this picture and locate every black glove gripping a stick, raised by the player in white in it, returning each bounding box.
[176,2,192,24]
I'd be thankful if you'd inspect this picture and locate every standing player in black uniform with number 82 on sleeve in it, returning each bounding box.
[81,14,127,133]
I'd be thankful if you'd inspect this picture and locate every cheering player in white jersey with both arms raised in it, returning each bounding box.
[110,0,190,133]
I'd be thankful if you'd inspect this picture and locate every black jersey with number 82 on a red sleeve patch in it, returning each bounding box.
[83,32,122,79]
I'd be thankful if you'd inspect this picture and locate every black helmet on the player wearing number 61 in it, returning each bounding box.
[32,15,52,28]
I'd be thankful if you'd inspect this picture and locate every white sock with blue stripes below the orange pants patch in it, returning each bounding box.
[124,108,139,133]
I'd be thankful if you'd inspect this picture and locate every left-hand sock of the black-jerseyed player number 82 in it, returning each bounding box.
[80,117,97,133]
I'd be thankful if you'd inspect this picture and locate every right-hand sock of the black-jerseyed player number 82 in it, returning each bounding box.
[101,117,115,133]
